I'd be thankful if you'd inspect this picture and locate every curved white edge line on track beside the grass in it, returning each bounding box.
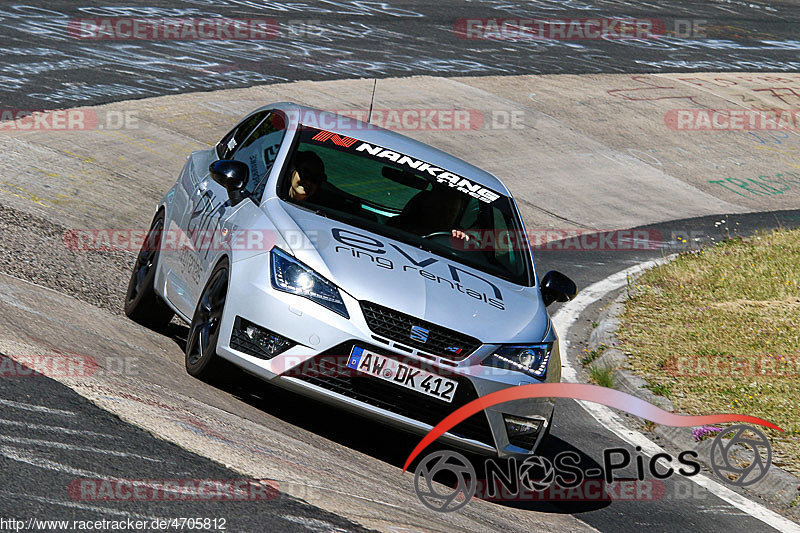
[553,258,800,533]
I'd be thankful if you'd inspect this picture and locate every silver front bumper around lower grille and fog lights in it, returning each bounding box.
[217,254,561,456]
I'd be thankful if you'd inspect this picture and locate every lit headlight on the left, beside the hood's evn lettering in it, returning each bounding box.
[270,247,350,318]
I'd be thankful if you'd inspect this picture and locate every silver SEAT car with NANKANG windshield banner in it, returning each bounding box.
[125,103,576,456]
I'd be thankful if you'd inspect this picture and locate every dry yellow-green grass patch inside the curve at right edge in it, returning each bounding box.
[618,230,800,474]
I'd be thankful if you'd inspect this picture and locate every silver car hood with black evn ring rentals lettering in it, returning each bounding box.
[273,202,548,344]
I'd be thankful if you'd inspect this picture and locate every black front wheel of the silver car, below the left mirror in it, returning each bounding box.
[185,260,229,381]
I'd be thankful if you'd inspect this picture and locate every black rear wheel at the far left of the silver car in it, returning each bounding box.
[125,211,175,329]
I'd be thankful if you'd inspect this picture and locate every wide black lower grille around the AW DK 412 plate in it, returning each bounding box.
[295,341,494,446]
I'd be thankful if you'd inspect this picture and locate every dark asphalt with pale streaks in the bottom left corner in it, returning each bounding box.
[0,356,366,531]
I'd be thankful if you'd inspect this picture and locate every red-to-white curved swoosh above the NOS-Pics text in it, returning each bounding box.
[403,383,783,472]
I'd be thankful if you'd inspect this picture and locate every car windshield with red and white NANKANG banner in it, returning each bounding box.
[279,126,532,285]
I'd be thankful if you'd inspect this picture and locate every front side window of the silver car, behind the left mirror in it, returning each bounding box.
[231,112,286,203]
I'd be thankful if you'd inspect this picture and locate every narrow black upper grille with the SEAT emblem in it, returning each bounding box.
[361,302,481,361]
